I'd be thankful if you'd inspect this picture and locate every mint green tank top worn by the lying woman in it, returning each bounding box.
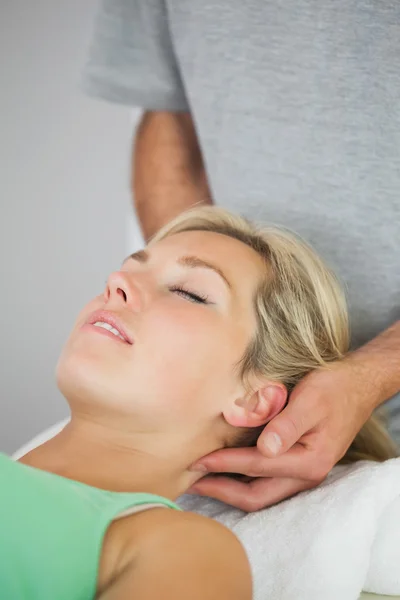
[0,453,181,600]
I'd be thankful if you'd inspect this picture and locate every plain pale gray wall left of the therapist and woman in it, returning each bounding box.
[0,0,144,452]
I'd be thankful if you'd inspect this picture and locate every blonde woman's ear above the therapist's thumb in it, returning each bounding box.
[223,382,287,427]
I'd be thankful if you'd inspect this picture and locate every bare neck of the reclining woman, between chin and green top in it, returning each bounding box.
[20,418,207,500]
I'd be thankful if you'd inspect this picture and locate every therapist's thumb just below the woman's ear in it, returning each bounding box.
[257,398,318,457]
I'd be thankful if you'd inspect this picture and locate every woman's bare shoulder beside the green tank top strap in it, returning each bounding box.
[100,508,252,600]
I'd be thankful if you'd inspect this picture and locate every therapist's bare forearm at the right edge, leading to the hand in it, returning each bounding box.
[348,321,400,408]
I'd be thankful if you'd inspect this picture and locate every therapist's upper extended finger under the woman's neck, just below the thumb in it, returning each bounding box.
[192,444,329,482]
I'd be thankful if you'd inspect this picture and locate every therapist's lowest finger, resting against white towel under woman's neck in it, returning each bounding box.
[191,476,315,512]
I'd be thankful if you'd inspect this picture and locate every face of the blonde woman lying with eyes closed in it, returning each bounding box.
[57,231,264,428]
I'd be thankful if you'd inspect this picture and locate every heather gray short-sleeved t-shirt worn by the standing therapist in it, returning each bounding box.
[84,0,400,408]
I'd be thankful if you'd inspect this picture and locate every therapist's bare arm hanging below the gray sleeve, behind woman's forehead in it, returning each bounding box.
[131,111,212,241]
